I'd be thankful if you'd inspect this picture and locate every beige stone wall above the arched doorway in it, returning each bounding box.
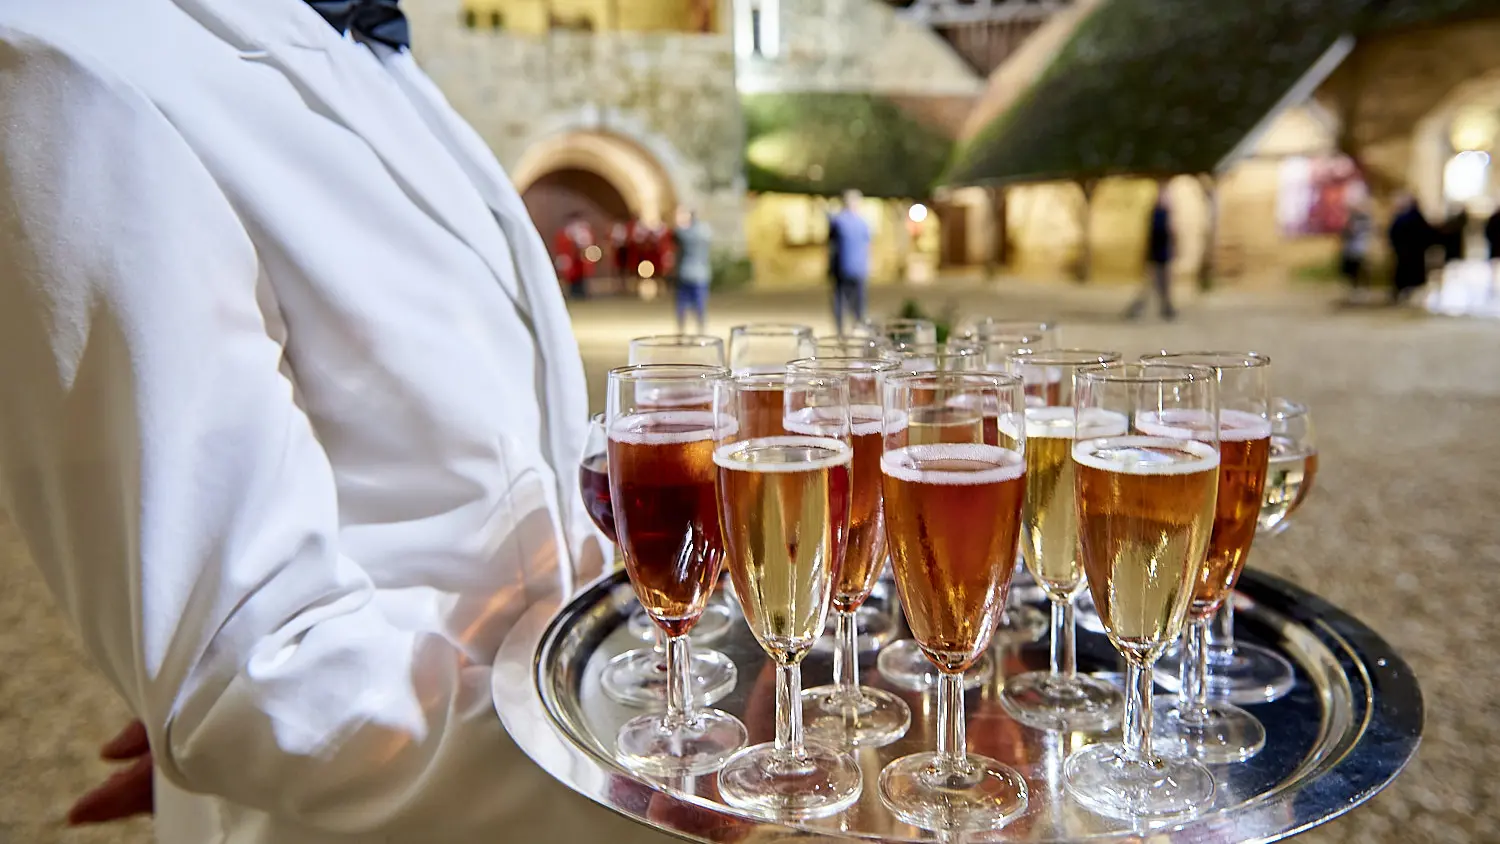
[402,0,744,244]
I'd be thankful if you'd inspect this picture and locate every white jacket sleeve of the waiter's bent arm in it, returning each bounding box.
[0,27,522,841]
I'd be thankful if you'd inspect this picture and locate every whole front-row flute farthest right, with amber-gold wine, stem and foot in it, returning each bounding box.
[1064,363,1220,819]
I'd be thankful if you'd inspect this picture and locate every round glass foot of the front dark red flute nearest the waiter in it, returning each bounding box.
[615,709,750,777]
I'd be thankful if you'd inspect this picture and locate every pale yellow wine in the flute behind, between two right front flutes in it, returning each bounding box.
[1020,408,1128,601]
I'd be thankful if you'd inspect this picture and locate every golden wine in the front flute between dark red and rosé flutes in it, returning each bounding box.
[714,436,854,663]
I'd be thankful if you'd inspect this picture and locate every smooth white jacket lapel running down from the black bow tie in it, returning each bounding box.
[177,0,518,307]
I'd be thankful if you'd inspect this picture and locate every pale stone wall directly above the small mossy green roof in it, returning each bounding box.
[740,0,984,94]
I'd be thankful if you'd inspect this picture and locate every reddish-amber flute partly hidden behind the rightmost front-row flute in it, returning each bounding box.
[1137,352,1271,763]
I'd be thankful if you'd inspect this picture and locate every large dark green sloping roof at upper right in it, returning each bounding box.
[944,0,1500,184]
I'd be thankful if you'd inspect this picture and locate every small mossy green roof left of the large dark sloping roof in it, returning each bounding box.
[740,93,953,199]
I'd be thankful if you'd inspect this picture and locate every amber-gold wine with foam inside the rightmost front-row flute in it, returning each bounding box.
[1073,436,1218,663]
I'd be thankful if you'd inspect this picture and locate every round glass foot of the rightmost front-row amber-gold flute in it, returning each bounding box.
[1064,745,1214,820]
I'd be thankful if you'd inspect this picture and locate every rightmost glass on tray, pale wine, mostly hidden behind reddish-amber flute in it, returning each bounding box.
[1169,399,1317,705]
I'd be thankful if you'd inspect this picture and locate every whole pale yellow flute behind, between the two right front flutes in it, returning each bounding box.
[1001,349,1128,732]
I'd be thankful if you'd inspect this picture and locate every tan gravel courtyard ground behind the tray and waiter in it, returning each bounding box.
[0,277,1500,844]
